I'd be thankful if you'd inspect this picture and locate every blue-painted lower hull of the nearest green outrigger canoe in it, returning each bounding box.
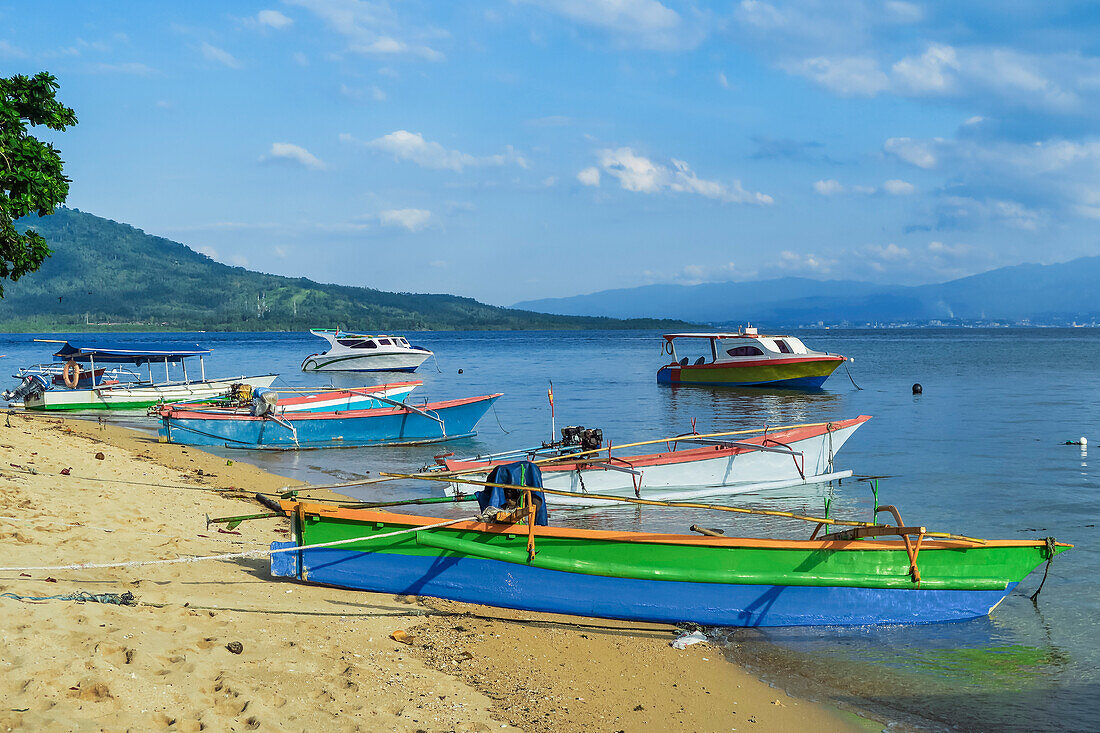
[272,543,1016,626]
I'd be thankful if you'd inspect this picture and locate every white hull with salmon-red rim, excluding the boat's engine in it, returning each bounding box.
[441,415,870,499]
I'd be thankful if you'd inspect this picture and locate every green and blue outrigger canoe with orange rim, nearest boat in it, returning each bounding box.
[272,501,1070,626]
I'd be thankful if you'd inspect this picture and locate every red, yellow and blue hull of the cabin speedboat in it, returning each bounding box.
[657,355,845,390]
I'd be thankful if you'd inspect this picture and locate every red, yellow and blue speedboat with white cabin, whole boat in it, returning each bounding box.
[657,327,846,390]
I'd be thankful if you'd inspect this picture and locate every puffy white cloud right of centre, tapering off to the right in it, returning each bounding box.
[598,147,773,205]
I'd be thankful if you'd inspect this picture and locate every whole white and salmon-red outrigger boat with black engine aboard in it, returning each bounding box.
[426,415,871,506]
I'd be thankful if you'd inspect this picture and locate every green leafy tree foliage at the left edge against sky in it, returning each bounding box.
[0,72,76,297]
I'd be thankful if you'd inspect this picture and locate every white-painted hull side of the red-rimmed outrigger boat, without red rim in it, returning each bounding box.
[442,423,862,506]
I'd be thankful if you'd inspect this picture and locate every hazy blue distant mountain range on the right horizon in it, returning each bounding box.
[514,256,1100,325]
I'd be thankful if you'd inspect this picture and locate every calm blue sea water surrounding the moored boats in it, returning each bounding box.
[0,329,1100,731]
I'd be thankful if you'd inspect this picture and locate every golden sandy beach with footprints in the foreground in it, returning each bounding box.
[0,413,882,731]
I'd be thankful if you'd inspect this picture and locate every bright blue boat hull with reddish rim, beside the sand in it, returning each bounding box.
[160,394,501,449]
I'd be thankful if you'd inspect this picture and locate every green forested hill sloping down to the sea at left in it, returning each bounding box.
[0,209,682,332]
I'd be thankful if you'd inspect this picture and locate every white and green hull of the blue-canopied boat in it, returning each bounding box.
[23,374,278,411]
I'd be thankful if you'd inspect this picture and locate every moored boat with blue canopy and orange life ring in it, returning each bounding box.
[0,339,278,411]
